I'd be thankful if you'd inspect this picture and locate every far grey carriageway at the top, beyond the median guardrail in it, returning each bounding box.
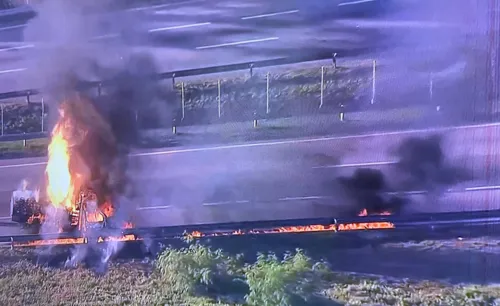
[0,0,487,91]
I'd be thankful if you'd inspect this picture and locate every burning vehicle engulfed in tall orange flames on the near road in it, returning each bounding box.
[11,94,131,232]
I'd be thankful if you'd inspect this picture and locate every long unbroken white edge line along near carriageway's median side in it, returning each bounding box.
[0,123,500,169]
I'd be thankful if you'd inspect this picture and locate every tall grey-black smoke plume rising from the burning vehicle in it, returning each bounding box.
[24,0,170,265]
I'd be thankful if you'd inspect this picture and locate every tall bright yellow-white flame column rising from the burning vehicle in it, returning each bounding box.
[45,122,74,209]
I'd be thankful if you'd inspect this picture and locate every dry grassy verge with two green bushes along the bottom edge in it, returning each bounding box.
[0,239,500,306]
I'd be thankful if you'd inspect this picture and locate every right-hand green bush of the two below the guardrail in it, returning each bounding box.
[245,250,325,306]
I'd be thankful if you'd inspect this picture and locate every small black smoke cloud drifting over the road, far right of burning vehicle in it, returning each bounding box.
[338,135,471,214]
